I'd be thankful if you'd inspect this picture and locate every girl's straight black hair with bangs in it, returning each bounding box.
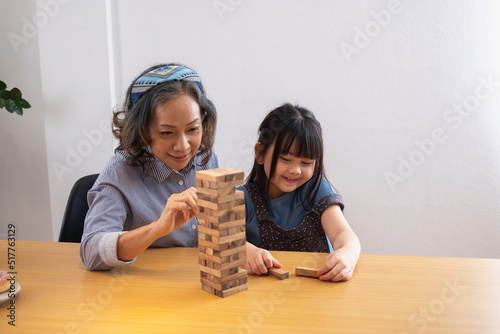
[246,103,326,210]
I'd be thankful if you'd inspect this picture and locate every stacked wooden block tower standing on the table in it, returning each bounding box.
[195,168,248,297]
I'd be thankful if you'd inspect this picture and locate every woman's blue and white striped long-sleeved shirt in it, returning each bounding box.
[80,151,218,270]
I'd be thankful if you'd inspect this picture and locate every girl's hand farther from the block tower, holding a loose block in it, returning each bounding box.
[318,248,357,282]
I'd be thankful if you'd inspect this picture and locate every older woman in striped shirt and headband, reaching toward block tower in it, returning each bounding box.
[80,64,218,270]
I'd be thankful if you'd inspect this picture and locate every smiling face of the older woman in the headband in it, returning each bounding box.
[149,94,203,171]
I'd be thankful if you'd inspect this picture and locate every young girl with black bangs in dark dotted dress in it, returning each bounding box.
[242,104,361,281]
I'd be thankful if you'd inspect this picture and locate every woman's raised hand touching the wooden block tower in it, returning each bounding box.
[156,187,199,236]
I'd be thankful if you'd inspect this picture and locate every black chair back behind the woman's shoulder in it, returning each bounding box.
[59,174,99,242]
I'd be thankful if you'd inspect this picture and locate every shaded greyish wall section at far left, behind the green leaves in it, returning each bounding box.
[0,1,52,240]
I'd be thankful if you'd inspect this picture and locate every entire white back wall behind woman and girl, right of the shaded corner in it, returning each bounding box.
[2,0,500,257]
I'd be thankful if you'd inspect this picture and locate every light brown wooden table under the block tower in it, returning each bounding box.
[0,240,500,334]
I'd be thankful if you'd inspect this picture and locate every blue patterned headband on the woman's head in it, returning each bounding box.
[130,65,205,104]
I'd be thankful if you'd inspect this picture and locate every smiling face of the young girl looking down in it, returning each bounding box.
[255,138,316,198]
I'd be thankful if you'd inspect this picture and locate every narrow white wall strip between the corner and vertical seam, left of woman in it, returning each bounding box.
[38,0,113,243]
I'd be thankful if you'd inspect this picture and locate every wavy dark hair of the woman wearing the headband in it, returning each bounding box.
[112,63,217,169]
